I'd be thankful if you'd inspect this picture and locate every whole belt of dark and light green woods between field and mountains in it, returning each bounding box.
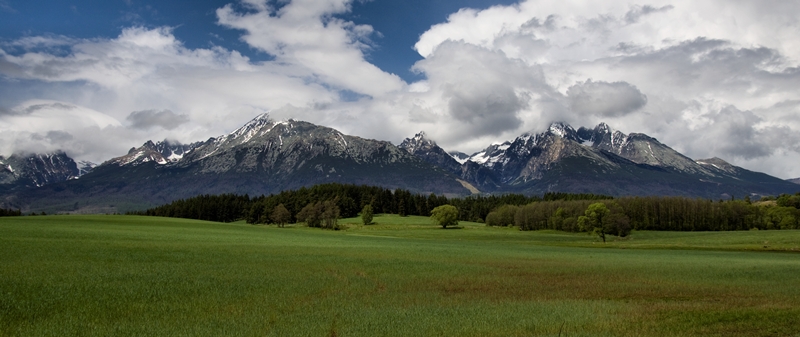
[138,184,800,232]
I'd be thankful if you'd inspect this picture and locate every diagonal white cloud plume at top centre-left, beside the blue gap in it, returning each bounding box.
[217,0,405,96]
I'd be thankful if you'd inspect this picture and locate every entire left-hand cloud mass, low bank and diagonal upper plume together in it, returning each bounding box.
[0,0,406,160]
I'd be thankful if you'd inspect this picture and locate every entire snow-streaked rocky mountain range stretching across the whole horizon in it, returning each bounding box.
[0,114,800,212]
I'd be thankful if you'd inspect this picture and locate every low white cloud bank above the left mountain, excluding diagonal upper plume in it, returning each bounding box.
[0,27,338,160]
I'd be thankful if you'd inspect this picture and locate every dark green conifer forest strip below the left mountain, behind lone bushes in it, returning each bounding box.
[136,183,610,224]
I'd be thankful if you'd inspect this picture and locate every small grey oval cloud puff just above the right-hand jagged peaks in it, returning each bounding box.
[567,80,647,117]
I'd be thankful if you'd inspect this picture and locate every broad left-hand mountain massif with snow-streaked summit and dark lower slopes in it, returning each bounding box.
[4,115,469,210]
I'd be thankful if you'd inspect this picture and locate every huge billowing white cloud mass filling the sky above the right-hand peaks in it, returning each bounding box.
[415,0,800,177]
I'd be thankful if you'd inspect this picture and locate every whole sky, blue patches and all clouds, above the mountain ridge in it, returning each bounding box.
[0,0,800,178]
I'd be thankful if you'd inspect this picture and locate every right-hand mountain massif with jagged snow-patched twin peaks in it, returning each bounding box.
[406,123,798,198]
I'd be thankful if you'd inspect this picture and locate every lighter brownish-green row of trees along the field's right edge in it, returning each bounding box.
[486,193,800,232]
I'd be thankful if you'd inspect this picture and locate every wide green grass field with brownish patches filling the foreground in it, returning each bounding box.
[0,215,800,336]
